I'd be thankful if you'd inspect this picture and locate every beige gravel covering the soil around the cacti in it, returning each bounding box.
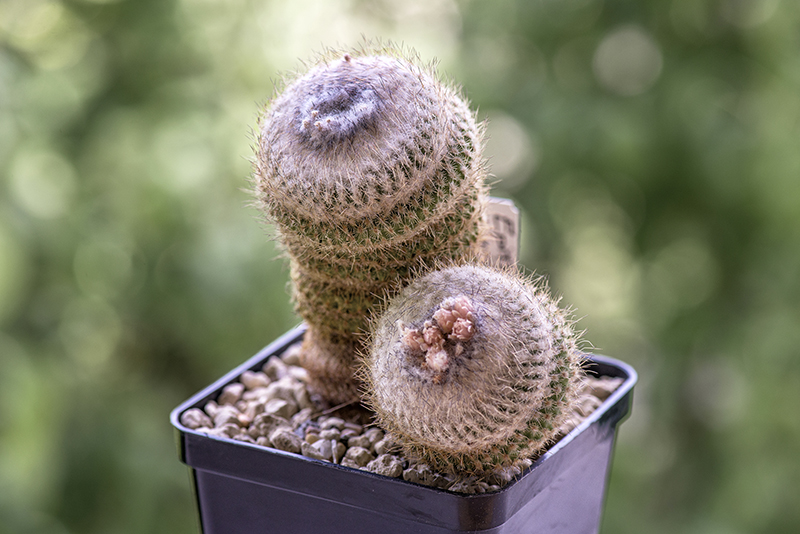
[180,343,623,494]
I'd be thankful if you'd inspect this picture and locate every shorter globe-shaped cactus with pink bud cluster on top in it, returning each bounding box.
[361,265,582,474]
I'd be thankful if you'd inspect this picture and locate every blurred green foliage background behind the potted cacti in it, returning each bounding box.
[0,0,800,534]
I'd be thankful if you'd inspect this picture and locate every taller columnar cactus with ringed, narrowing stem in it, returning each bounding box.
[254,48,487,403]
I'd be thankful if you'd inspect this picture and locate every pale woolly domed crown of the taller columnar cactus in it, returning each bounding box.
[259,54,468,231]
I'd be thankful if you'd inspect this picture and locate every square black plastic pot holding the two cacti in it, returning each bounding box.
[171,327,637,534]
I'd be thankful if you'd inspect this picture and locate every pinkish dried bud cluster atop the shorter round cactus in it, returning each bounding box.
[403,295,475,381]
